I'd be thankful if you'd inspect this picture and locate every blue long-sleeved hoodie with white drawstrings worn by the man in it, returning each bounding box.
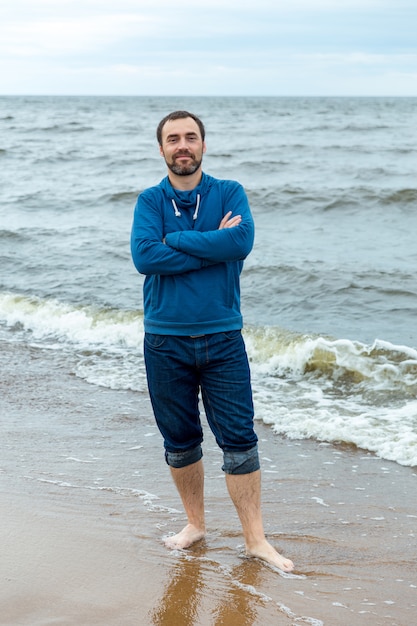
[131,173,254,335]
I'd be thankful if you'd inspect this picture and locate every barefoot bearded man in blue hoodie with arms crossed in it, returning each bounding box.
[131,111,294,572]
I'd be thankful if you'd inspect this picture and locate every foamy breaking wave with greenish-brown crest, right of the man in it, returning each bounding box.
[246,327,417,466]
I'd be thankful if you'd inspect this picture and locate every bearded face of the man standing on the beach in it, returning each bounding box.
[159,117,206,176]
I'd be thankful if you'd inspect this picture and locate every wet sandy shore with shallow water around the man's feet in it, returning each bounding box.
[0,345,417,626]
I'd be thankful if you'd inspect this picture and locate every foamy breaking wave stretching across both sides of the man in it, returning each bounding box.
[0,293,417,466]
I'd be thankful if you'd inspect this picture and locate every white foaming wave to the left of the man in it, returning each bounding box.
[0,293,146,391]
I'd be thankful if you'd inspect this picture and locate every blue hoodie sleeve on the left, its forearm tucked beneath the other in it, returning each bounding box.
[130,192,207,275]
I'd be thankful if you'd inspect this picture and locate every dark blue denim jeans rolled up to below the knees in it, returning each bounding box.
[144,330,259,474]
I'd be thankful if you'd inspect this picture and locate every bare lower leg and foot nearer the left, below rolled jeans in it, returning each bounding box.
[165,460,206,549]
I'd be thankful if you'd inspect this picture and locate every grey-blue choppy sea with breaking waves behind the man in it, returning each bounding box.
[0,96,417,467]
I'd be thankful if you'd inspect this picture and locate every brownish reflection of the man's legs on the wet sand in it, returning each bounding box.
[150,547,270,626]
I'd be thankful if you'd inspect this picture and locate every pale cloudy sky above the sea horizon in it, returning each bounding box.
[0,0,417,96]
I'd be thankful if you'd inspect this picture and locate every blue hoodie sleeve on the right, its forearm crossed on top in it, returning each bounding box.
[162,183,255,263]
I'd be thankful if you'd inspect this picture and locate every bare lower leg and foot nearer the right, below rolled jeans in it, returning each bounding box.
[226,470,294,572]
